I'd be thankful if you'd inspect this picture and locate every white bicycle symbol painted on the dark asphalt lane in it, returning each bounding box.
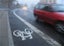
[13,28,33,40]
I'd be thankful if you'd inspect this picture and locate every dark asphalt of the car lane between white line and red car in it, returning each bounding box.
[16,9,64,46]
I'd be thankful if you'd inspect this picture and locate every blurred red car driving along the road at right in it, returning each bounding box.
[34,4,64,33]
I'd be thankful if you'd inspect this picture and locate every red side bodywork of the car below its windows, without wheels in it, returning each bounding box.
[34,4,64,24]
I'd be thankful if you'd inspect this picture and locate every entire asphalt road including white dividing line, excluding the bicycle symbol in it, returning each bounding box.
[9,9,64,46]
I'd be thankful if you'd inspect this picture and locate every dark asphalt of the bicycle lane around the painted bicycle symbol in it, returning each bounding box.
[9,12,51,46]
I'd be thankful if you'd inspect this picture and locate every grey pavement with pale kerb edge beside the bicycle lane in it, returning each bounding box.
[0,9,12,46]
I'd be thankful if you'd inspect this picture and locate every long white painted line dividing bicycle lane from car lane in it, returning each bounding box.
[13,9,61,46]
